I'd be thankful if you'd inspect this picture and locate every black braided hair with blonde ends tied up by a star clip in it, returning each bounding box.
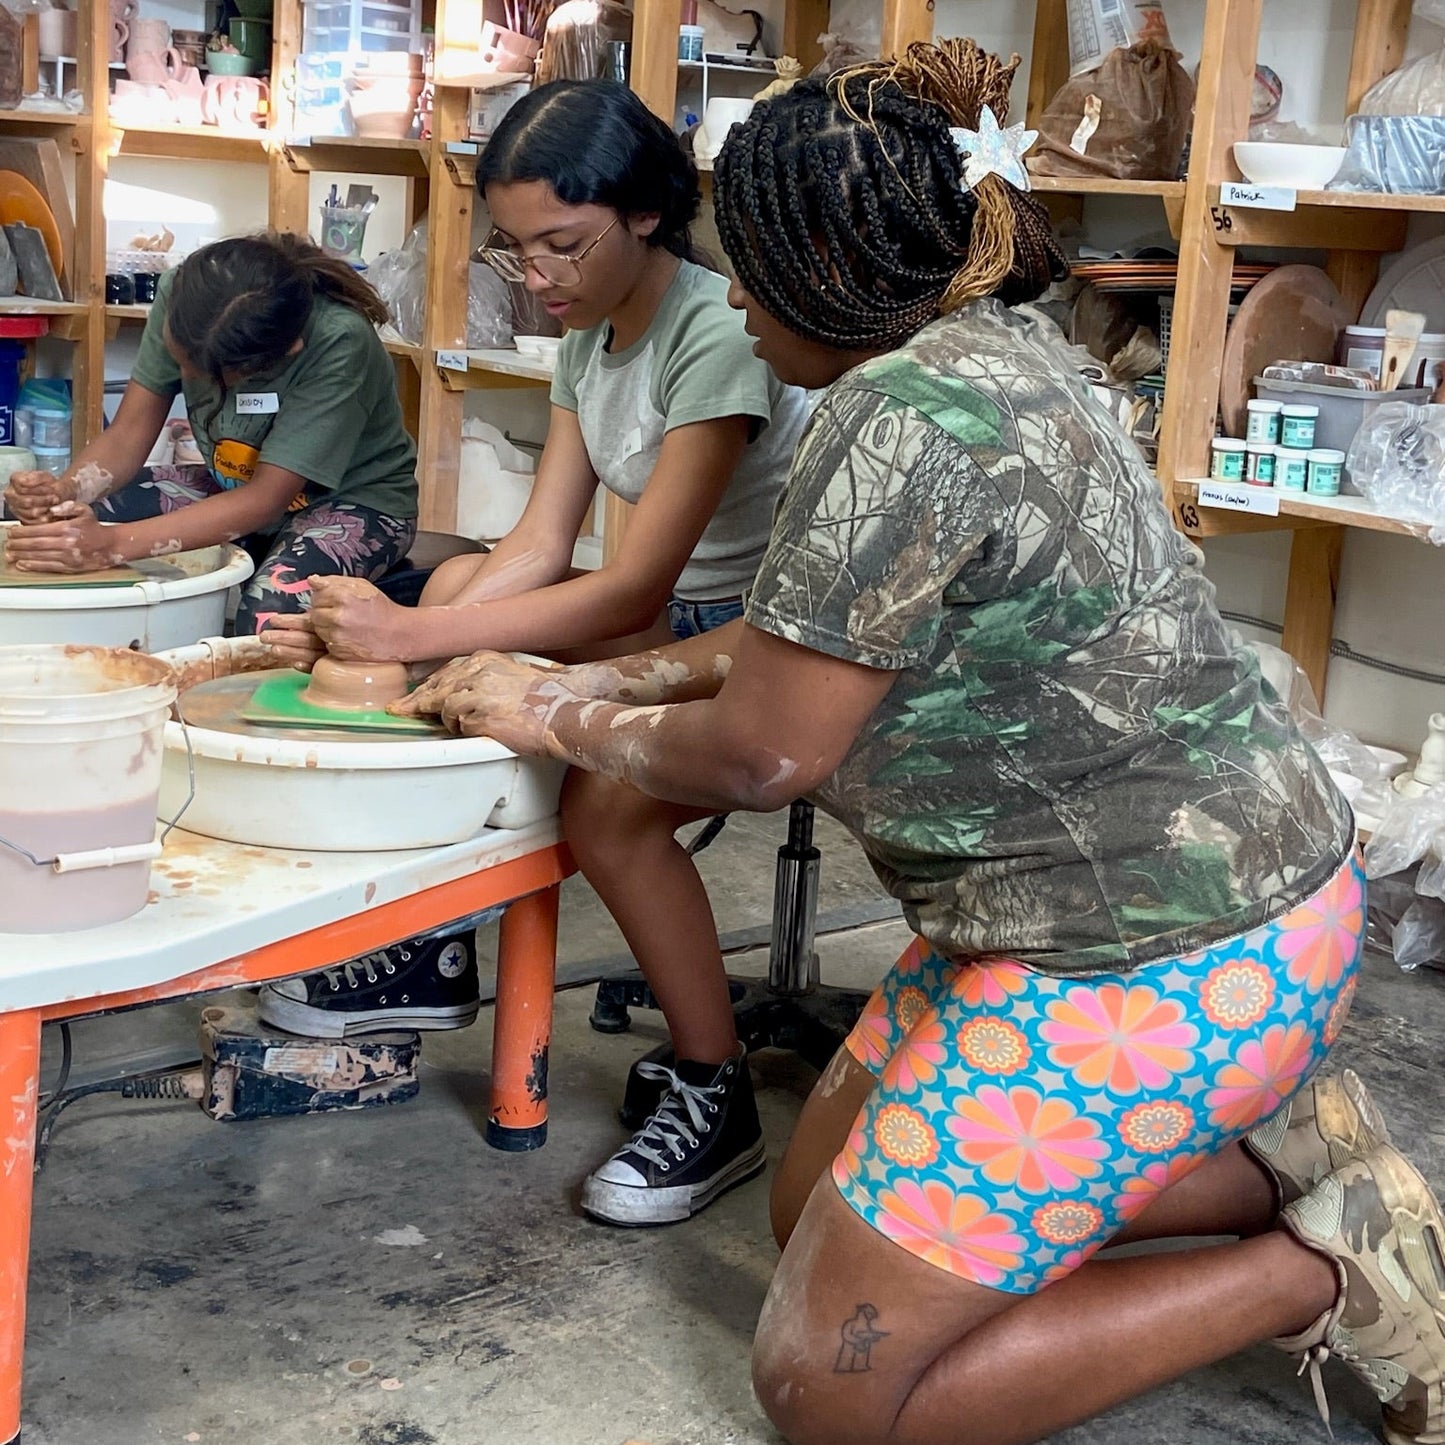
[714,40,1066,350]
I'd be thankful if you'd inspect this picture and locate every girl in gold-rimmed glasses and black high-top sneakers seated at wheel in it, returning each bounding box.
[262,81,806,1224]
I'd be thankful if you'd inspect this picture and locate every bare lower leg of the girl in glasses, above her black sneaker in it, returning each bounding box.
[562,769,738,1064]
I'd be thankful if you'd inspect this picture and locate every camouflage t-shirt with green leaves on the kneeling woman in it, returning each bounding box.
[747,301,1354,972]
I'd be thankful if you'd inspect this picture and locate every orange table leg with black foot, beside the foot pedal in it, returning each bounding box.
[487,886,561,1152]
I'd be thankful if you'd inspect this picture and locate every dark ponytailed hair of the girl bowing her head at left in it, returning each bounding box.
[166,231,387,396]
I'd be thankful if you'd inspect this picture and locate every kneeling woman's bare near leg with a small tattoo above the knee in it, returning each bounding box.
[753,1179,1338,1445]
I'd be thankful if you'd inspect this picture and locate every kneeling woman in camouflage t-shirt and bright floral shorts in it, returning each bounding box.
[400,42,1445,1445]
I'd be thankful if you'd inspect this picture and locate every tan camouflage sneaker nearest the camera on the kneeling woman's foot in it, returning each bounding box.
[1274,1144,1445,1445]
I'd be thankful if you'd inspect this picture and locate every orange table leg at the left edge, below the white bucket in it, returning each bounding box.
[0,1010,40,1445]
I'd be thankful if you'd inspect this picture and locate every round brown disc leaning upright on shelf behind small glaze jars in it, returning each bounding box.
[1220,266,1354,436]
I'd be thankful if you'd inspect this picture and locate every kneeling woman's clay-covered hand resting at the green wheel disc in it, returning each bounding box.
[387,652,557,756]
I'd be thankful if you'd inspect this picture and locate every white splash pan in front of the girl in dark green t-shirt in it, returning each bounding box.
[0,522,254,652]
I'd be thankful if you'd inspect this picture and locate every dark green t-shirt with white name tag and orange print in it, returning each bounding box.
[130,272,416,520]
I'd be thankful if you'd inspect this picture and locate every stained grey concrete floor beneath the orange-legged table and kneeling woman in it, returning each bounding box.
[25,818,1445,1445]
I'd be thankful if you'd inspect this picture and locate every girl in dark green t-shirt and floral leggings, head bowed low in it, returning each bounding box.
[6,234,416,633]
